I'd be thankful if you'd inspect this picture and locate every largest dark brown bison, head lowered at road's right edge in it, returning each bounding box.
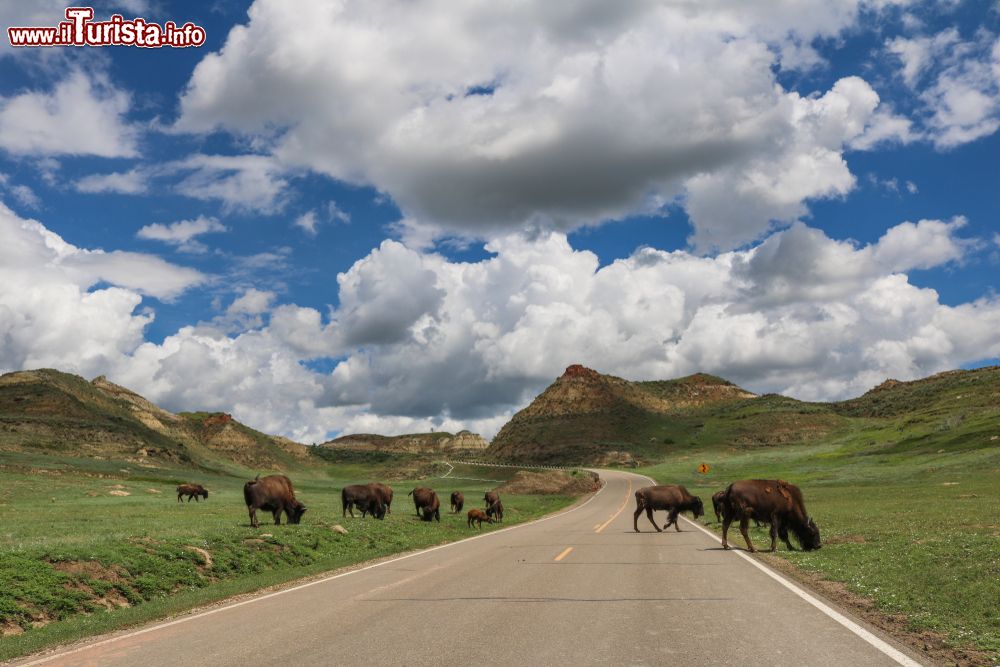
[722,479,822,551]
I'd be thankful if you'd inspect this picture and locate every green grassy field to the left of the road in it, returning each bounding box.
[0,454,572,660]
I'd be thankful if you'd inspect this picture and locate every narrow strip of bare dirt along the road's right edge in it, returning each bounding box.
[758,552,995,667]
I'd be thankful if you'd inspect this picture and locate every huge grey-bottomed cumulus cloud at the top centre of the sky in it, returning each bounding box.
[177,0,906,250]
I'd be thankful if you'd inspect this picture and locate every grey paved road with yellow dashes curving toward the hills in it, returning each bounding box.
[23,472,914,667]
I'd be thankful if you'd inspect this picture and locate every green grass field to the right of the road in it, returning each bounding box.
[641,426,1000,660]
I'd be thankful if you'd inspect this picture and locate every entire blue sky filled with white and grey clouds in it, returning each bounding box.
[0,0,1000,443]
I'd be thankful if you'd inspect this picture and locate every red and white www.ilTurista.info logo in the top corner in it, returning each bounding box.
[7,7,205,49]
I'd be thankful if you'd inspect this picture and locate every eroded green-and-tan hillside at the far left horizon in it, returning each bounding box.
[0,369,312,469]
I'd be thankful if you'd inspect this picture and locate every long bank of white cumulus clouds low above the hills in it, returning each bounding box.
[0,198,1000,442]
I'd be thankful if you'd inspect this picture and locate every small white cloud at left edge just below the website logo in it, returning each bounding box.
[0,69,138,157]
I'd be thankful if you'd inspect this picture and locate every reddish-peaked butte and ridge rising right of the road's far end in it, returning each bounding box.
[487,366,1000,465]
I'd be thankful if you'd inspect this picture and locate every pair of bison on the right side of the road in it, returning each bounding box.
[632,479,821,551]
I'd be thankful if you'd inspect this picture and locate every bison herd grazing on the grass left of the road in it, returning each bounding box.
[177,475,508,529]
